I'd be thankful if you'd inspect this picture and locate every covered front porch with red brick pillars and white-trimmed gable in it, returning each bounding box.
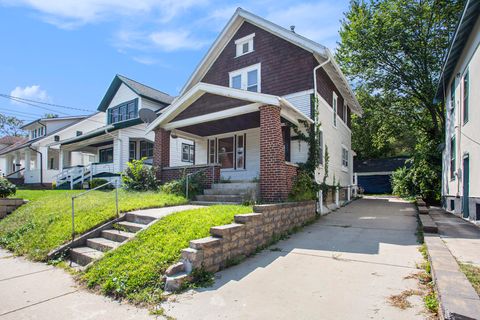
[149,83,312,201]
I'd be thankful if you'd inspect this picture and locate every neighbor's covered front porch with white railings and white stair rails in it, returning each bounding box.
[55,122,153,188]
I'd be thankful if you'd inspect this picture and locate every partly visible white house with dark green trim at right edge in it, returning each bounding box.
[437,1,480,221]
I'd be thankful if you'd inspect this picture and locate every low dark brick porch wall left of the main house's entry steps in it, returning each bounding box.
[161,164,220,189]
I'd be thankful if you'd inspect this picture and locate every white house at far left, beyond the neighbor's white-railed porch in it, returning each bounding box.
[0,115,96,185]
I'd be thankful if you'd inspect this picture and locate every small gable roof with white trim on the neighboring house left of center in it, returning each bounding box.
[98,74,173,111]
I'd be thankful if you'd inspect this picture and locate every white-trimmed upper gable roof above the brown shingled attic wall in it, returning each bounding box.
[180,8,362,113]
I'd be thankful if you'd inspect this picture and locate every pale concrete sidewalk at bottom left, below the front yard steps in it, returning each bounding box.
[0,249,152,320]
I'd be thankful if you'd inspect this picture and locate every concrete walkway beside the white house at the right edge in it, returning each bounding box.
[430,209,480,267]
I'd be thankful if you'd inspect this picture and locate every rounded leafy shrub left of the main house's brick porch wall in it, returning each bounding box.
[122,158,158,191]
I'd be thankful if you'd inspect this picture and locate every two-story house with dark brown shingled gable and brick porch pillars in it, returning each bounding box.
[147,8,362,201]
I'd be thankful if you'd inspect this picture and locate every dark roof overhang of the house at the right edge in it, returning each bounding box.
[435,0,480,100]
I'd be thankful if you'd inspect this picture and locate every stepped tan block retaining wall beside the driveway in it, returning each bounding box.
[179,201,316,275]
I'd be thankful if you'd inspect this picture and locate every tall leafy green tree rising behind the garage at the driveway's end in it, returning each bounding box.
[337,0,464,199]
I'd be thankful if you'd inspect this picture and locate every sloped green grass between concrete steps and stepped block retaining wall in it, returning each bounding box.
[81,205,252,304]
